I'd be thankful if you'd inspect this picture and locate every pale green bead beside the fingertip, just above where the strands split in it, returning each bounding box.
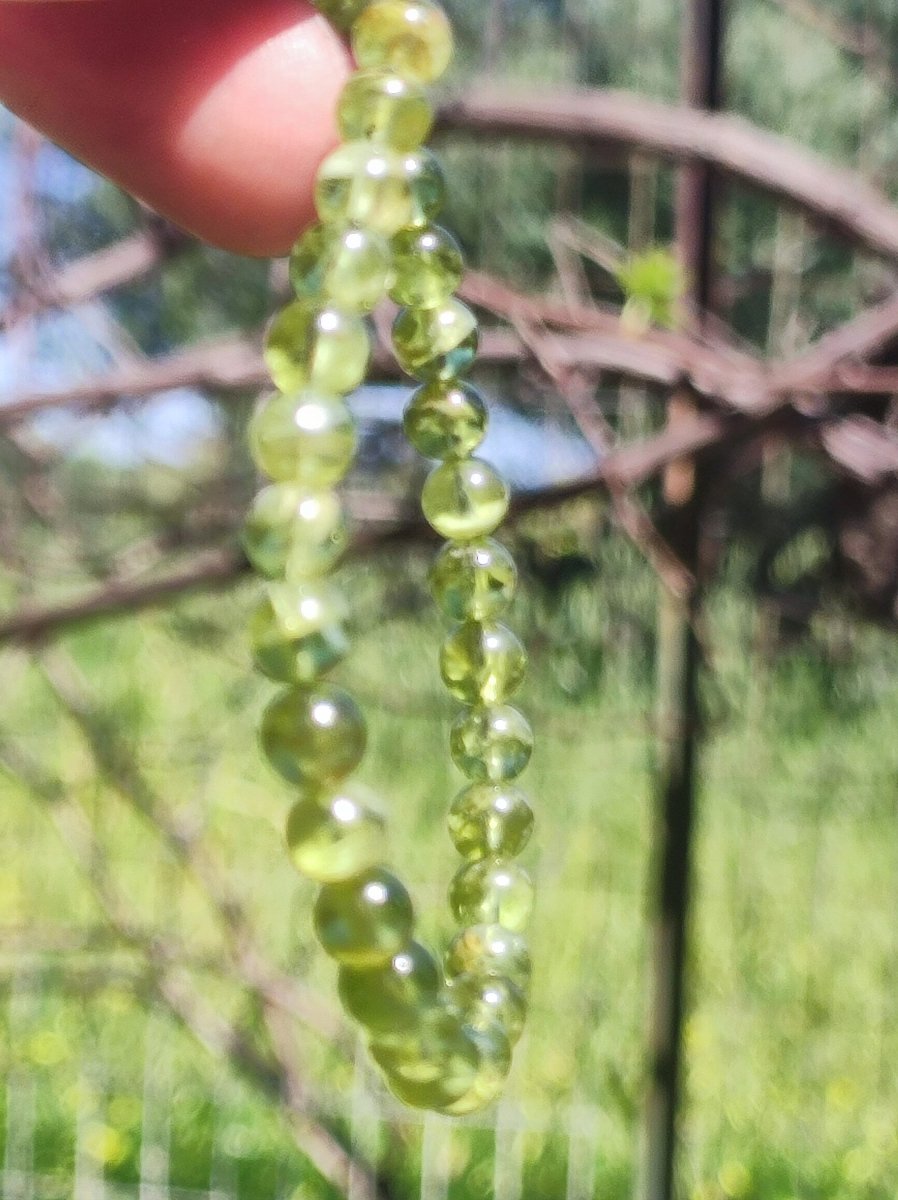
[315,142,415,236]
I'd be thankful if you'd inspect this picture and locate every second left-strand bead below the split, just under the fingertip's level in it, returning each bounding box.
[264,300,371,394]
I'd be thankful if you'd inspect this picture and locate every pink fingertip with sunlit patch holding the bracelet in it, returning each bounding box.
[0,0,351,254]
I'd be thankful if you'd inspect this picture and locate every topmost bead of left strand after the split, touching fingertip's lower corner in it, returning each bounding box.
[291,224,393,312]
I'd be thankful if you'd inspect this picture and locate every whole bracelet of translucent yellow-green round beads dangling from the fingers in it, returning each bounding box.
[244,0,533,1115]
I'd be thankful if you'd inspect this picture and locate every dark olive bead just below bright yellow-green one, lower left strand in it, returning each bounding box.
[315,866,414,967]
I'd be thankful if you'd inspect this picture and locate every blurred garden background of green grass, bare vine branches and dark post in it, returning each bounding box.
[0,0,898,1200]
